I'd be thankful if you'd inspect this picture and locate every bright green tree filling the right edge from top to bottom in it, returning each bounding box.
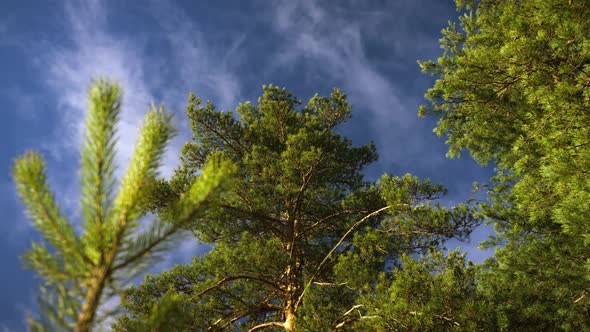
[421,0,590,331]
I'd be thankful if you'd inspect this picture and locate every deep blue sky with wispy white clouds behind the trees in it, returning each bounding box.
[0,0,491,331]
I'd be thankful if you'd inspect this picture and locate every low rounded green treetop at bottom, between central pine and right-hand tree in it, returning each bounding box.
[350,251,490,331]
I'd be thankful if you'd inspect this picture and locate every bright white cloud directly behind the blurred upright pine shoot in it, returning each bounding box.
[41,1,153,175]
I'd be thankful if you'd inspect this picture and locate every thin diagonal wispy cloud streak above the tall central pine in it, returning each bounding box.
[271,0,416,165]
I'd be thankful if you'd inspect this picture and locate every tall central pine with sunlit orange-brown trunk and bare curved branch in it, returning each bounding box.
[114,86,478,331]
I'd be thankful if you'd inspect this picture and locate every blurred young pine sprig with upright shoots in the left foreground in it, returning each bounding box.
[13,80,231,332]
